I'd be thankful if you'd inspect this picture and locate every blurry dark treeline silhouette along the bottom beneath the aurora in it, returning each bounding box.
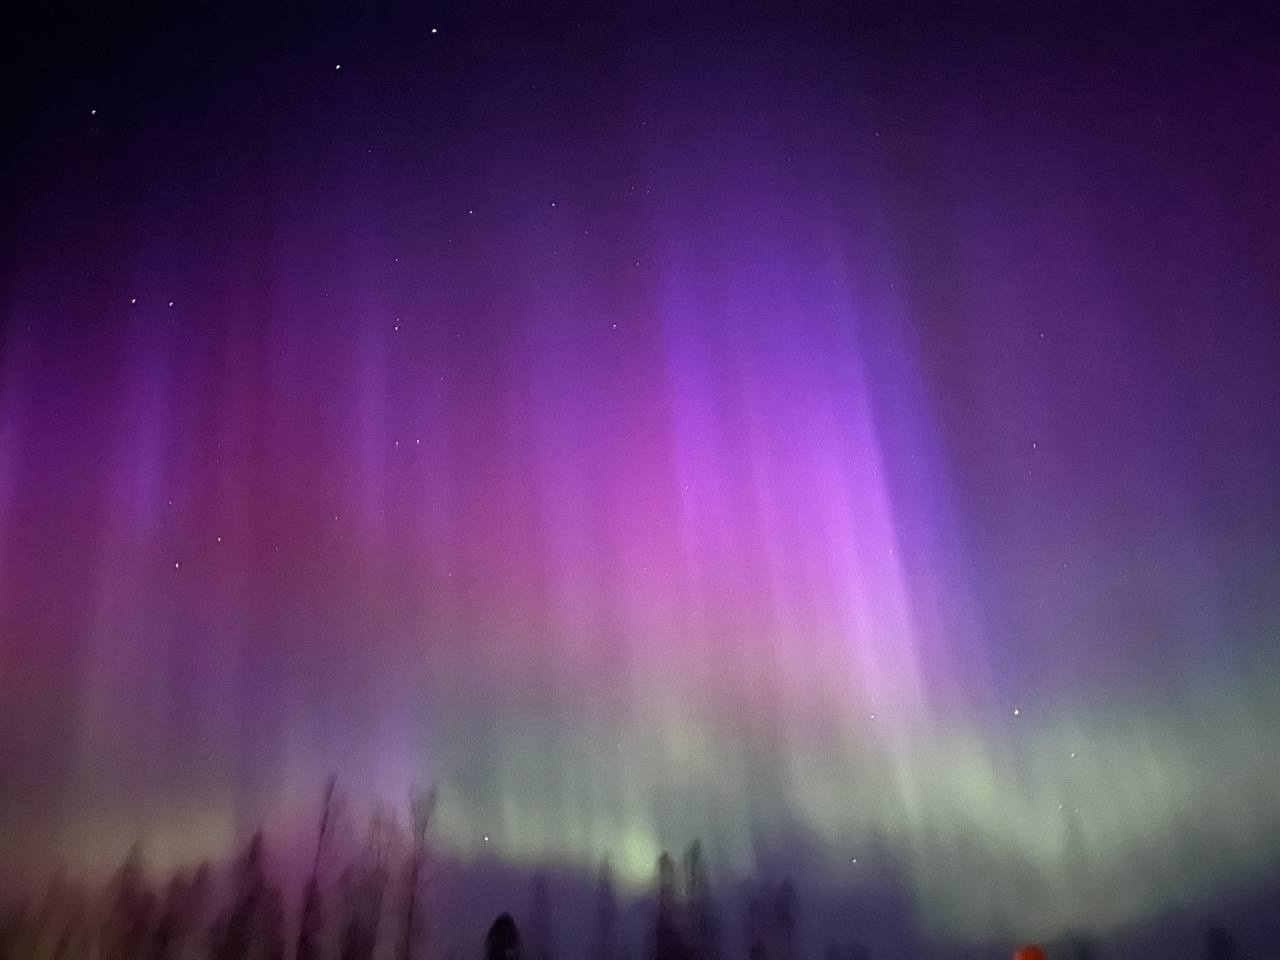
[0,778,1240,960]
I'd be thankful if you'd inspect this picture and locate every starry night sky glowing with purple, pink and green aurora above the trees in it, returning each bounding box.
[0,4,1280,938]
